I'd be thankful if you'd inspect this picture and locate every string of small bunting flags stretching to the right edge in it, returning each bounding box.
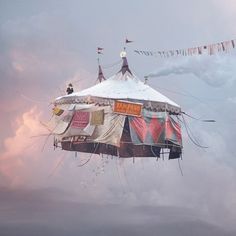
[134,39,236,58]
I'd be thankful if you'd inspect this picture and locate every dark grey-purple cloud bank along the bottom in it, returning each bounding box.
[0,187,235,236]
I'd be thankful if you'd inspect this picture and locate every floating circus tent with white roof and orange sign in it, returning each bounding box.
[49,55,182,159]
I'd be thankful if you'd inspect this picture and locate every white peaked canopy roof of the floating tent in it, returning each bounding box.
[56,57,180,113]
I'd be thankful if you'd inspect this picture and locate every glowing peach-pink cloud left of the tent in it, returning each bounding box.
[0,107,47,186]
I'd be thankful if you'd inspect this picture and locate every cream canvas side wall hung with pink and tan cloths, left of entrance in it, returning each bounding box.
[52,106,125,146]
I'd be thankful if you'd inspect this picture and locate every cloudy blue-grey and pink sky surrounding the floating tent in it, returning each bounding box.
[0,0,236,236]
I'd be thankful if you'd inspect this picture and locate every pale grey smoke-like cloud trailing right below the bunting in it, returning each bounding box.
[147,55,236,87]
